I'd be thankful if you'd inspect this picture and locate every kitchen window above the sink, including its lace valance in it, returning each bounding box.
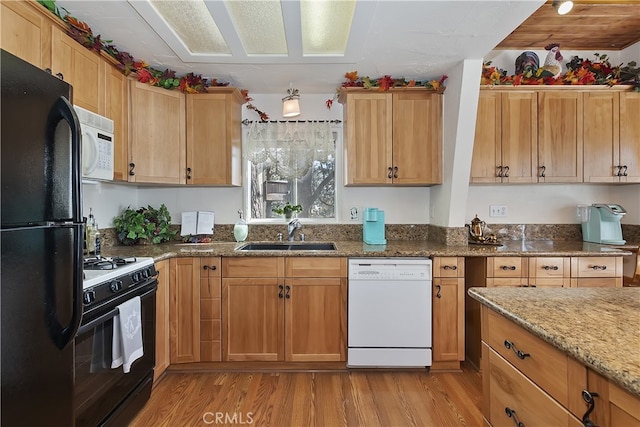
[243,122,341,222]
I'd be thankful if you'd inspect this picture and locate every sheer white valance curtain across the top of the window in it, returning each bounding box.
[242,122,336,179]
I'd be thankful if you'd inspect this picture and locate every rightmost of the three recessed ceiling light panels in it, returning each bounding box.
[300,0,356,55]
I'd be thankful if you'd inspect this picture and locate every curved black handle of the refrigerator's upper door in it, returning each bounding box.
[47,96,82,223]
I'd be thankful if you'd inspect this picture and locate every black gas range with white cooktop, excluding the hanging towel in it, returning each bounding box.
[74,257,158,427]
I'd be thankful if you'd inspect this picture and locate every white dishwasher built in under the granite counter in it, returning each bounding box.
[347,258,432,368]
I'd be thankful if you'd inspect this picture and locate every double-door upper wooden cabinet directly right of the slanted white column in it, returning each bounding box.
[469,90,538,184]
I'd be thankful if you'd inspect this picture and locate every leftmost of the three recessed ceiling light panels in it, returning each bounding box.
[149,0,231,55]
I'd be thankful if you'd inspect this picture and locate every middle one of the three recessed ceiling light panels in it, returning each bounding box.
[224,0,288,55]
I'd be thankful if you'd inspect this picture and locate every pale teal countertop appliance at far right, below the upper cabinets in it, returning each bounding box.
[582,203,627,245]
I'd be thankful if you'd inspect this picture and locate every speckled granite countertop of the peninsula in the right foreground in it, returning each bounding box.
[469,287,640,397]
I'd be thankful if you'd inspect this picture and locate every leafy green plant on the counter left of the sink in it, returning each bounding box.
[113,204,178,245]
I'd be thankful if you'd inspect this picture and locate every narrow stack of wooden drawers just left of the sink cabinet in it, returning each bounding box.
[200,257,222,362]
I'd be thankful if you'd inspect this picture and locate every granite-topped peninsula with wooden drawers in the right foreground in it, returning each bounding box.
[468,287,640,426]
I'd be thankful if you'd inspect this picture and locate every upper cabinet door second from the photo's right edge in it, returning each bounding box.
[584,92,616,182]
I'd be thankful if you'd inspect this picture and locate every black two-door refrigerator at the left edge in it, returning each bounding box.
[0,50,83,427]
